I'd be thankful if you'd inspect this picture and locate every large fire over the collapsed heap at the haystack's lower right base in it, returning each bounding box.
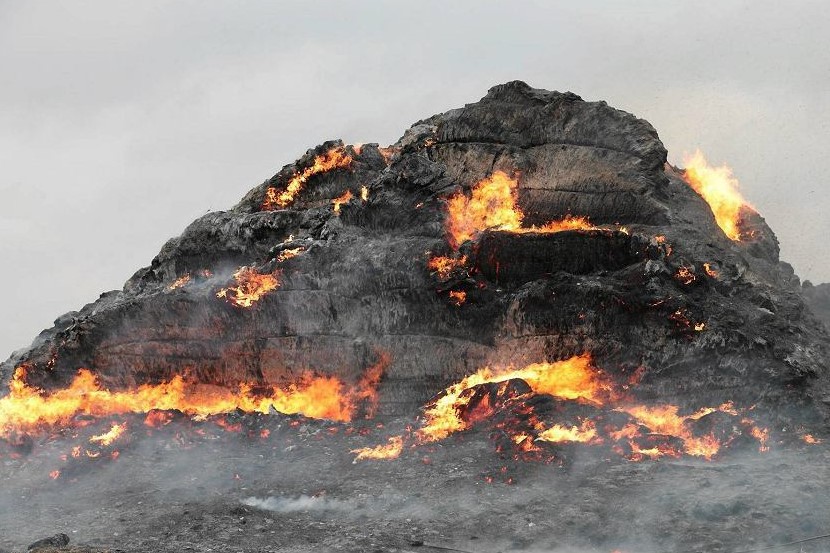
[353,354,769,461]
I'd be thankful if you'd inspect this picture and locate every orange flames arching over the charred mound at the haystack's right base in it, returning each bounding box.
[353,354,769,460]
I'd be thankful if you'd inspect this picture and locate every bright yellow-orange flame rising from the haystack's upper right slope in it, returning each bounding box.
[684,150,754,241]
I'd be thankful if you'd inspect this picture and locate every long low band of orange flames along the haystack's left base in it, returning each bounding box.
[0,357,388,436]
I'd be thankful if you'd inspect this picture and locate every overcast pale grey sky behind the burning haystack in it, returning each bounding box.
[0,0,830,358]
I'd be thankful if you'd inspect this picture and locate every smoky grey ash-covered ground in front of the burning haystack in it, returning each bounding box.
[0,417,830,553]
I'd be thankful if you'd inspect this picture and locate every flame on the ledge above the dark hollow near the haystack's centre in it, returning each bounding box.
[446,171,597,248]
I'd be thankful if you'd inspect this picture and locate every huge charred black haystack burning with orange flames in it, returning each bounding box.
[0,81,830,552]
